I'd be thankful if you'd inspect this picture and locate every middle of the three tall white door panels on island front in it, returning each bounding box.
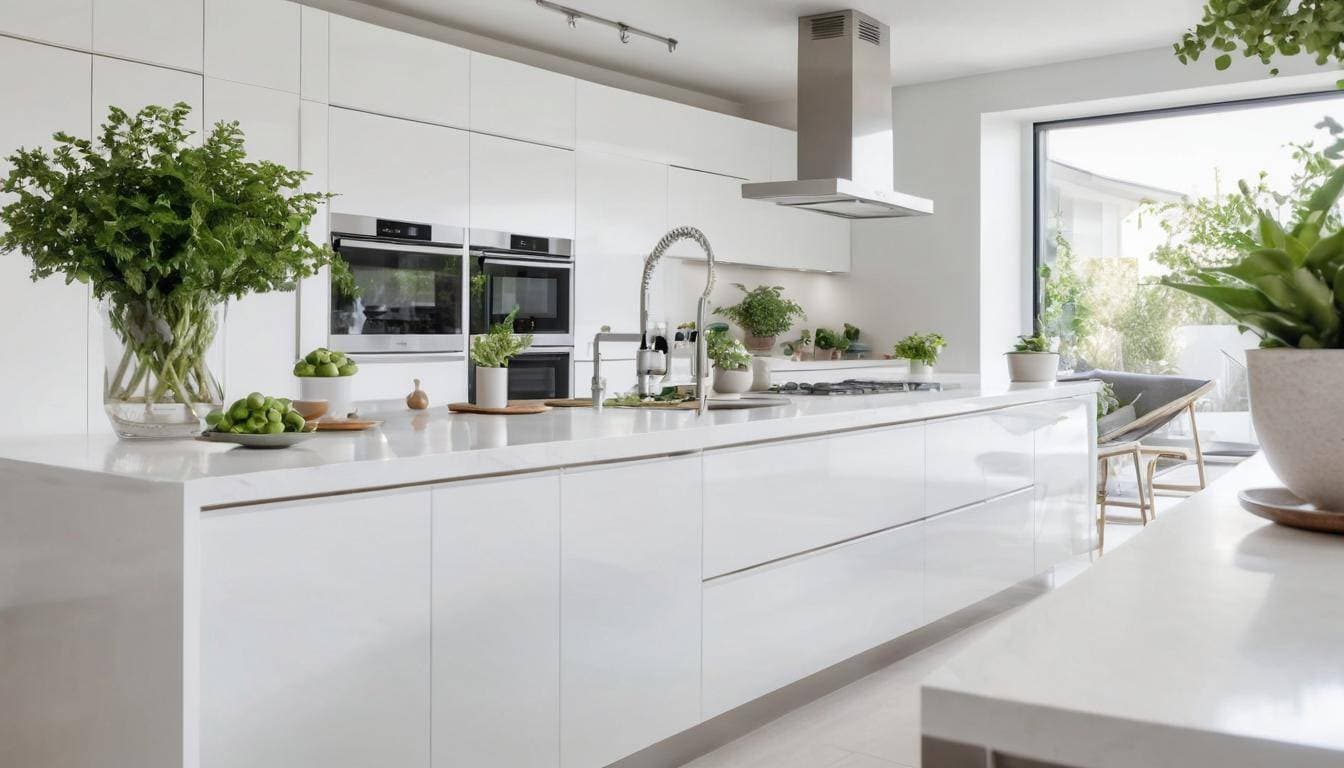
[433,472,560,768]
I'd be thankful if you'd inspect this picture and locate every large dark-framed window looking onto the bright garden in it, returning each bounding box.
[1035,93,1344,444]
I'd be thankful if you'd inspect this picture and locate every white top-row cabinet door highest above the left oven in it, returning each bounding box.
[329,16,470,128]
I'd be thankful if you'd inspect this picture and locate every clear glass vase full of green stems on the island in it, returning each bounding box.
[101,296,224,438]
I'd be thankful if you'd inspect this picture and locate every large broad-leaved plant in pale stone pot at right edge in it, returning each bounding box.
[1163,129,1344,511]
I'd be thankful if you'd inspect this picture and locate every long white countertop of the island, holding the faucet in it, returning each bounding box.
[0,382,1095,506]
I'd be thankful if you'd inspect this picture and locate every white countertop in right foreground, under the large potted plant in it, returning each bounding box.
[922,456,1344,768]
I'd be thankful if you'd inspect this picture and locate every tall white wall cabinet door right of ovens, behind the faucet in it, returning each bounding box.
[574,151,668,357]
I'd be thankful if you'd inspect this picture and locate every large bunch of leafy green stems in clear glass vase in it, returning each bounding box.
[0,104,352,437]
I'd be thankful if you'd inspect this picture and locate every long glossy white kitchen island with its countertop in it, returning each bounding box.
[0,383,1095,768]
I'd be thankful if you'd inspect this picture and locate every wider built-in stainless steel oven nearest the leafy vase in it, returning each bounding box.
[328,214,466,352]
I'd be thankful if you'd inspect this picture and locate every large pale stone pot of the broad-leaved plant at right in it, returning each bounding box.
[1246,350,1344,512]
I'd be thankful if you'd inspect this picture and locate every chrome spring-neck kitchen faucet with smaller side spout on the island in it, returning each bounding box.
[593,227,714,413]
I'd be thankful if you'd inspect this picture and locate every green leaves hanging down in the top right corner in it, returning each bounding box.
[1175,0,1344,82]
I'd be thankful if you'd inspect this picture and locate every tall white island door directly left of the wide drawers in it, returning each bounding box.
[560,456,700,768]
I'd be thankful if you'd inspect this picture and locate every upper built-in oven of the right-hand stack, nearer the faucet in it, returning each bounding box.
[470,229,574,344]
